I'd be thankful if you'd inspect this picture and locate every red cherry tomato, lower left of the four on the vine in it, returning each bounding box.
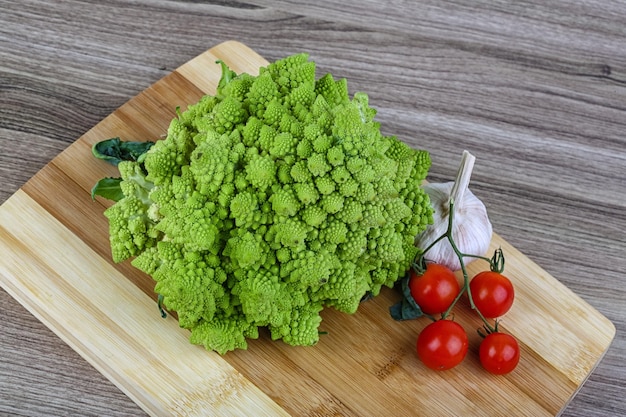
[417,320,469,371]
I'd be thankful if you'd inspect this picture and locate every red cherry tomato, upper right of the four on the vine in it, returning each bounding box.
[469,271,515,319]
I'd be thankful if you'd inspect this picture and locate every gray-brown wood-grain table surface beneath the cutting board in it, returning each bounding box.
[0,0,626,417]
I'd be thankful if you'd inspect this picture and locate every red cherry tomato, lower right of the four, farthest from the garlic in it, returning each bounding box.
[478,332,520,375]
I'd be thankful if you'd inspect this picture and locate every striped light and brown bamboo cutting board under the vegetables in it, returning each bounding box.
[0,41,615,417]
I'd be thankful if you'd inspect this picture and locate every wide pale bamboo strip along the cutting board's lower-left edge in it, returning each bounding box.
[1,191,284,416]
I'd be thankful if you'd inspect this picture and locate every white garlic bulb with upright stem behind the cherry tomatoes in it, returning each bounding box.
[415,151,492,271]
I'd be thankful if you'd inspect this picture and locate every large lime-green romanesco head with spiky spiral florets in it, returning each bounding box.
[97,54,432,354]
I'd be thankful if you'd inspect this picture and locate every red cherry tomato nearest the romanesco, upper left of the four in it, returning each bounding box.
[409,263,461,314]
